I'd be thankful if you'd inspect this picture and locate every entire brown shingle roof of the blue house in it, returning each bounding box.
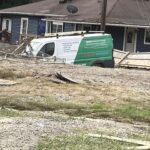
[0,0,150,26]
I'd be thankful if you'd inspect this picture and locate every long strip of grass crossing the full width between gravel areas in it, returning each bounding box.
[0,94,150,123]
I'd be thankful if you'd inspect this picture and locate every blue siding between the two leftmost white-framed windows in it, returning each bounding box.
[10,16,21,44]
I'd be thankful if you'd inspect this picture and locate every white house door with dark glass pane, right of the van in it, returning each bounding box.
[125,28,136,53]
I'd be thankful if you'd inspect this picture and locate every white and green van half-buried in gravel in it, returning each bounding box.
[26,33,114,67]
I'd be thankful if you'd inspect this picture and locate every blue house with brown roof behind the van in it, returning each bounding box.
[0,0,150,52]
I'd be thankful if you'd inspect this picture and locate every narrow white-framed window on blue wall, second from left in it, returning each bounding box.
[20,18,28,35]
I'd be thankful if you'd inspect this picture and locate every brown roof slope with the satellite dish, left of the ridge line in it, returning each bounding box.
[0,0,117,22]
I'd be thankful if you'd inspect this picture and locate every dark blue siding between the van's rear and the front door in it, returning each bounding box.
[106,26,124,50]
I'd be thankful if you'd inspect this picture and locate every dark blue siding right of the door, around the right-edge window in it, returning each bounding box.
[136,29,150,52]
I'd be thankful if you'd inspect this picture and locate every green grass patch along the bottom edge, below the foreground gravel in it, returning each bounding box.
[38,136,135,150]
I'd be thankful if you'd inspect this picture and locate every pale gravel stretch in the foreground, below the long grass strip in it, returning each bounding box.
[0,117,150,150]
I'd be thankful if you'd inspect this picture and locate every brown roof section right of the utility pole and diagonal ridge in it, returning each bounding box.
[107,0,150,27]
